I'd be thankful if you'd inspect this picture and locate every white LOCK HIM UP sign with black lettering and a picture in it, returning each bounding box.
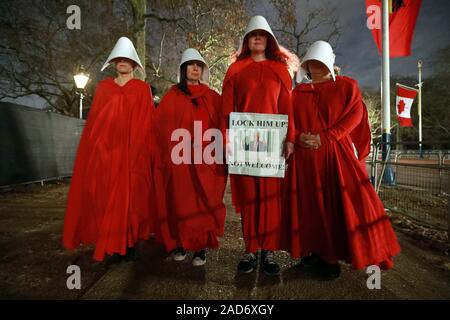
[227,112,288,178]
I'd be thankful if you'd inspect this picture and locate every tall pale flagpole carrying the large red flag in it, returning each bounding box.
[381,0,395,185]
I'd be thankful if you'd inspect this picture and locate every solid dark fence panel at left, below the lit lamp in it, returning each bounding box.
[0,102,84,186]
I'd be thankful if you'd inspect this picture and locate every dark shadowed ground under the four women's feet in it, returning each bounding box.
[0,183,450,299]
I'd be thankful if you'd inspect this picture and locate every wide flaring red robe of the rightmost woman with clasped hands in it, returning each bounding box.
[284,76,400,269]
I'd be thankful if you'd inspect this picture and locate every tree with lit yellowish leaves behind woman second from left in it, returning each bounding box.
[147,0,247,90]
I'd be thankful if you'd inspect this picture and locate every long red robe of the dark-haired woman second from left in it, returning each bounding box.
[153,85,226,251]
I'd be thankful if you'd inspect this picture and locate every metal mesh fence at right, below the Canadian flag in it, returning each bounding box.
[367,142,450,234]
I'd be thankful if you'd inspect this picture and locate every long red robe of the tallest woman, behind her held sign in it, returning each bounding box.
[222,57,295,252]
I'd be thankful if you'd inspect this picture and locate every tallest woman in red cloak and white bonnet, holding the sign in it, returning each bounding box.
[222,16,295,275]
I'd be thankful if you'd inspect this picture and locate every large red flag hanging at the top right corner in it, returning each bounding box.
[366,0,422,57]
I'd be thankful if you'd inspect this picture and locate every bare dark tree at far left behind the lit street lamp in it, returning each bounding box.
[0,0,133,115]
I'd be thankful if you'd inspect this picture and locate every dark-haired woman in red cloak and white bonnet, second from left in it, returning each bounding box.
[153,48,226,266]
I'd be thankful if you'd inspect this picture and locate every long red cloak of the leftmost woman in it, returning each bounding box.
[63,78,154,261]
